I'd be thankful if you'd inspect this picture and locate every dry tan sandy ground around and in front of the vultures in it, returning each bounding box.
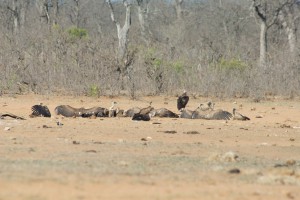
[0,95,300,200]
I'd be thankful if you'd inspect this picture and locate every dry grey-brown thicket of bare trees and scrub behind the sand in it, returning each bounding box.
[0,0,300,98]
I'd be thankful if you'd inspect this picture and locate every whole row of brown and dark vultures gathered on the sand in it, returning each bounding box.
[0,91,250,121]
